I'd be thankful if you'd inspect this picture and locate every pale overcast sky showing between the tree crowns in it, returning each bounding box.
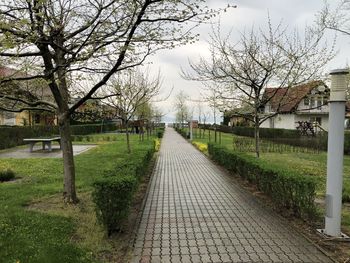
[149,0,350,122]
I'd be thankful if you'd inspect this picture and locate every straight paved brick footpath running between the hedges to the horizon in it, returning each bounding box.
[131,128,332,263]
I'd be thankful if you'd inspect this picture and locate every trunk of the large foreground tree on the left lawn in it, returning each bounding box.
[59,114,79,204]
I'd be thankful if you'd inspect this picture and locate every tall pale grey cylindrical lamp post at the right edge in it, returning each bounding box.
[324,69,349,237]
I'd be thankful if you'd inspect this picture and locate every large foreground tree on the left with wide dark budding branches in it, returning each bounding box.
[0,0,217,203]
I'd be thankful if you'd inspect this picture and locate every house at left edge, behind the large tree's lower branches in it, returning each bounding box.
[0,66,56,126]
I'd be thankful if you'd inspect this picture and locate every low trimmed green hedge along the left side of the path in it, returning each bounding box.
[92,148,154,236]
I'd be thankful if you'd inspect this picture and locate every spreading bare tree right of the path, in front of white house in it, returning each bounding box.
[184,20,333,157]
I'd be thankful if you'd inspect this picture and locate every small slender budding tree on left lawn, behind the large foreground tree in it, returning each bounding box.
[102,69,160,153]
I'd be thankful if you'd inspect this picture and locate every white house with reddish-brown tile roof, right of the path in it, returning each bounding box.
[260,81,330,130]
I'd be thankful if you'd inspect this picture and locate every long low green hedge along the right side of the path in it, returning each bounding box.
[208,143,317,218]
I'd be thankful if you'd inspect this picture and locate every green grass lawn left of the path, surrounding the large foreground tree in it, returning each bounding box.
[0,135,153,263]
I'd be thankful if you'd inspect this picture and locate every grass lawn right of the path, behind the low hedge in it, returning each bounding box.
[189,129,350,234]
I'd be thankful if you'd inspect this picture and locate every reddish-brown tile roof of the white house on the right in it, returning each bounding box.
[263,81,324,113]
